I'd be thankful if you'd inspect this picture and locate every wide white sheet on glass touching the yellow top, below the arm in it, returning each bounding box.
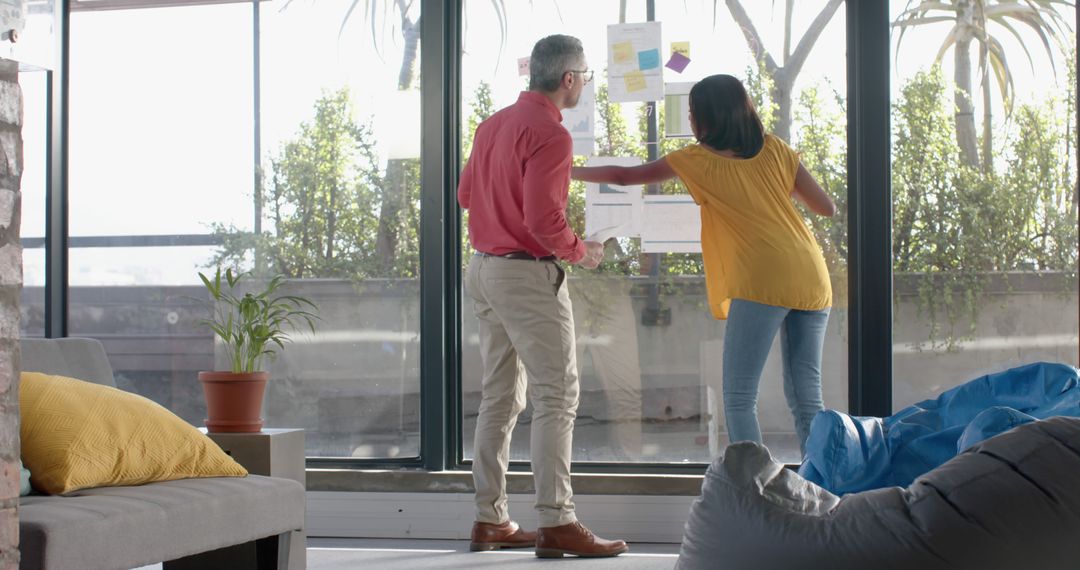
[642,194,701,254]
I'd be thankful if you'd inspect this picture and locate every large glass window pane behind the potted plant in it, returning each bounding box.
[69,0,420,458]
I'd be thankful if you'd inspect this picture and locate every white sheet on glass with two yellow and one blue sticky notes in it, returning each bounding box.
[607,22,664,103]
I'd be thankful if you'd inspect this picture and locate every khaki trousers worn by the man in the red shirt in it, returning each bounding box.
[465,255,579,527]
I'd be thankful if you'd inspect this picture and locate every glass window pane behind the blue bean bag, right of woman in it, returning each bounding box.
[891,0,1080,409]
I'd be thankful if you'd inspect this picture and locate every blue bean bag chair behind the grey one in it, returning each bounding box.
[799,363,1080,494]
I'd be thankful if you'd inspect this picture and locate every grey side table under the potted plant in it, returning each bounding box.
[200,428,308,570]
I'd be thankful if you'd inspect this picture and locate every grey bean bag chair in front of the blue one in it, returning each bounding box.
[676,417,1080,570]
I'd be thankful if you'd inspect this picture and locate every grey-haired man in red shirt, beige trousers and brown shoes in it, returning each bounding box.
[458,36,627,558]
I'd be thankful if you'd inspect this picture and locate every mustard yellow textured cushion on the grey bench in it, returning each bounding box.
[18,372,247,494]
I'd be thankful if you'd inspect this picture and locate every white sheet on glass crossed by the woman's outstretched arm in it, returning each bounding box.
[585,157,642,242]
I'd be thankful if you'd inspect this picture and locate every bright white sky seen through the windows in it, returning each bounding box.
[12,0,1074,285]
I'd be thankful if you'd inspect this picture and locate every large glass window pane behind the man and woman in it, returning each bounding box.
[461,0,848,462]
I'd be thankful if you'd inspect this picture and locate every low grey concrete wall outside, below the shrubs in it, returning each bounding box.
[26,269,1078,457]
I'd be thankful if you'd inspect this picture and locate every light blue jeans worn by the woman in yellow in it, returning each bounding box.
[724,299,828,451]
